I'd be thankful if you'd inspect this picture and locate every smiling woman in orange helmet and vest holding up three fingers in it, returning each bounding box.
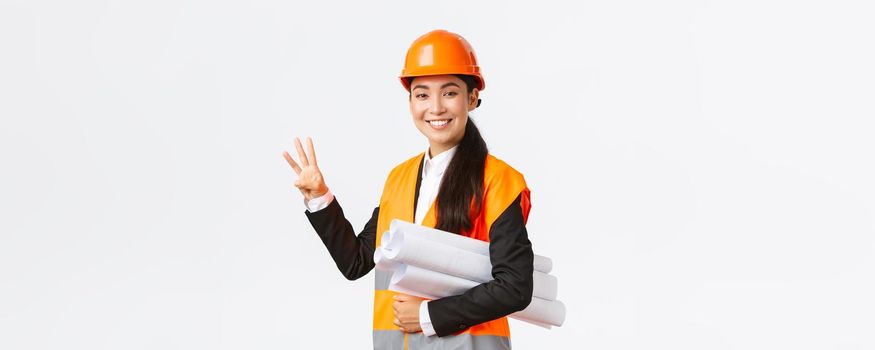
[283,30,534,349]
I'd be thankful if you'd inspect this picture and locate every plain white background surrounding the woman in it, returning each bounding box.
[0,0,875,349]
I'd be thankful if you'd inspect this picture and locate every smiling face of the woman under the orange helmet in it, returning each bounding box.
[410,75,479,156]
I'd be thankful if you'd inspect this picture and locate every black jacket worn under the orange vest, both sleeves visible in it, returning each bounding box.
[305,157,534,336]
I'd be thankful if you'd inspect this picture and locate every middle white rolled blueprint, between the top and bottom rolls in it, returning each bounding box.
[374,231,559,300]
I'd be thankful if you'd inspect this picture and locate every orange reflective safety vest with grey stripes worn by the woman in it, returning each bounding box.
[374,153,531,350]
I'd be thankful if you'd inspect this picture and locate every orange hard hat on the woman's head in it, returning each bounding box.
[399,29,486,91]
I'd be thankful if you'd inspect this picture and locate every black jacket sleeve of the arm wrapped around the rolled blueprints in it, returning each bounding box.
[428,195,535,337]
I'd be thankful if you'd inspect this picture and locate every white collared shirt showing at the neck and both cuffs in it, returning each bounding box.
[304,145,459,336]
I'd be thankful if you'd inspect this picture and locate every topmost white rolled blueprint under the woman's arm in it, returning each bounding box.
[390,219,553,274]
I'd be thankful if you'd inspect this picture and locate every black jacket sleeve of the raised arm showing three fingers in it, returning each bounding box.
[304,197,380,281]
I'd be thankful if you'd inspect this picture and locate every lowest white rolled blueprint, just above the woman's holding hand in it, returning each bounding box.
[389,264,565,328]
